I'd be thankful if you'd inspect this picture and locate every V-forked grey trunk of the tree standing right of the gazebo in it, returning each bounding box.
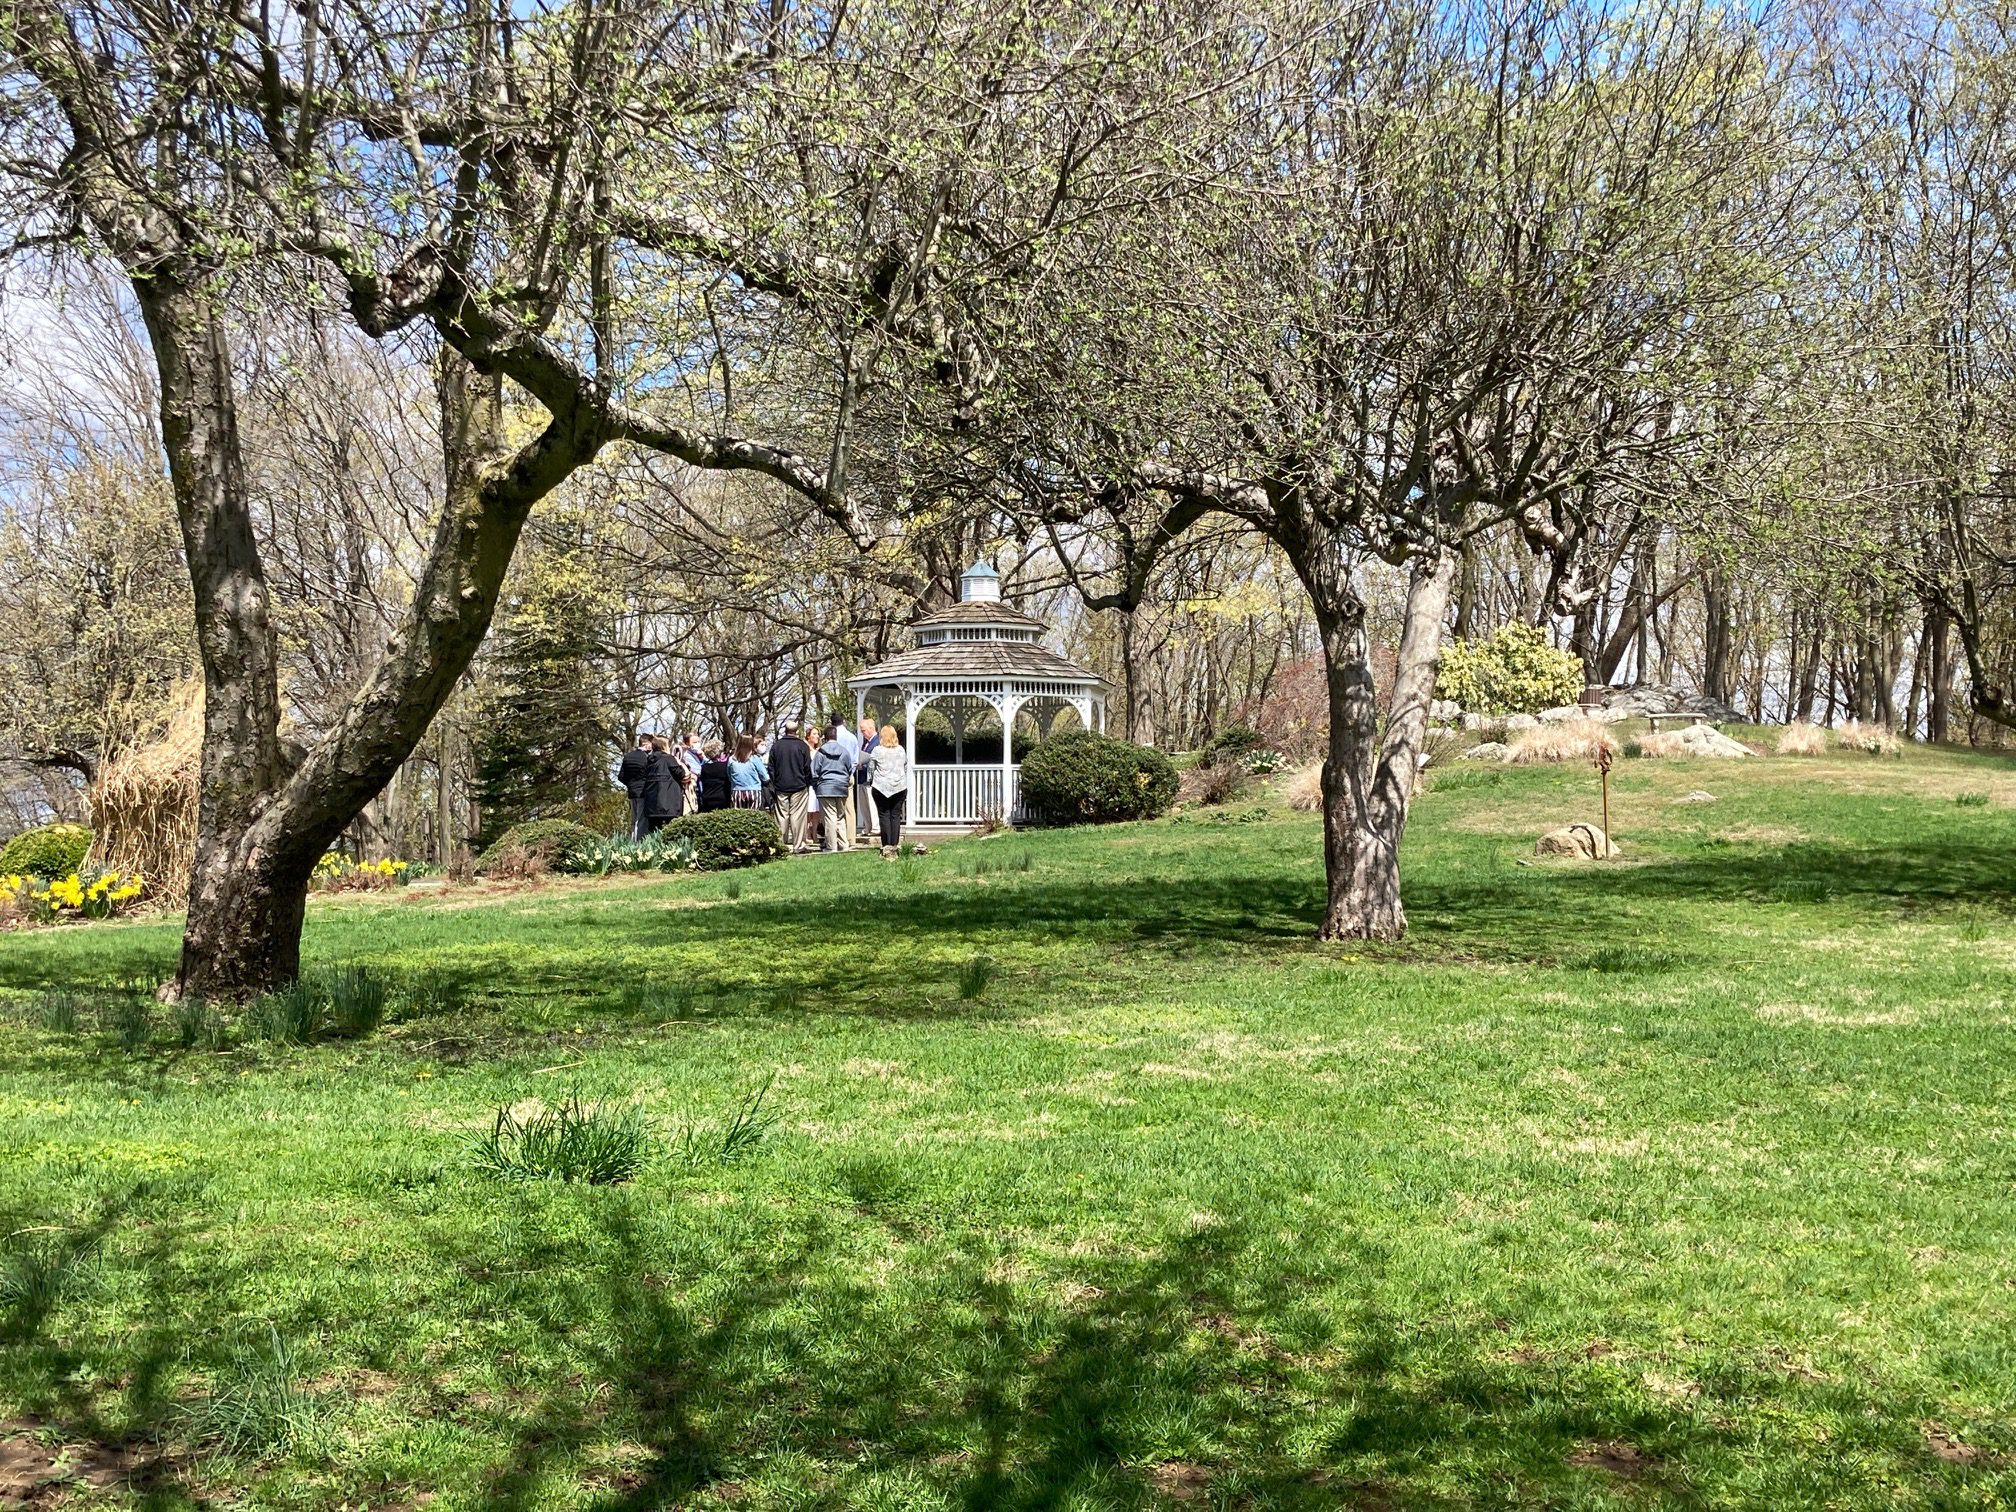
[1316,554,1456,939]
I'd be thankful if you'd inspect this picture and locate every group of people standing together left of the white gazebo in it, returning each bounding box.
[617,720,909,857]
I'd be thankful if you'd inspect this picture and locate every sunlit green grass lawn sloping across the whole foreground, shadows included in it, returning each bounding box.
[0,752,2016,1512]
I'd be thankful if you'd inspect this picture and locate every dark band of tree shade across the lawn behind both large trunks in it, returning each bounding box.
[0,843,2016,1020]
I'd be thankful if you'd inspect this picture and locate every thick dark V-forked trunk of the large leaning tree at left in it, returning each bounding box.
[161,330,584,998]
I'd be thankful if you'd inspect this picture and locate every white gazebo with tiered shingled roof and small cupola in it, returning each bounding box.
[847,562,1107,825]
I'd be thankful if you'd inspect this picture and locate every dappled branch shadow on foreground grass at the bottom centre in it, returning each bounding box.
[429,1212,1951,1512]
